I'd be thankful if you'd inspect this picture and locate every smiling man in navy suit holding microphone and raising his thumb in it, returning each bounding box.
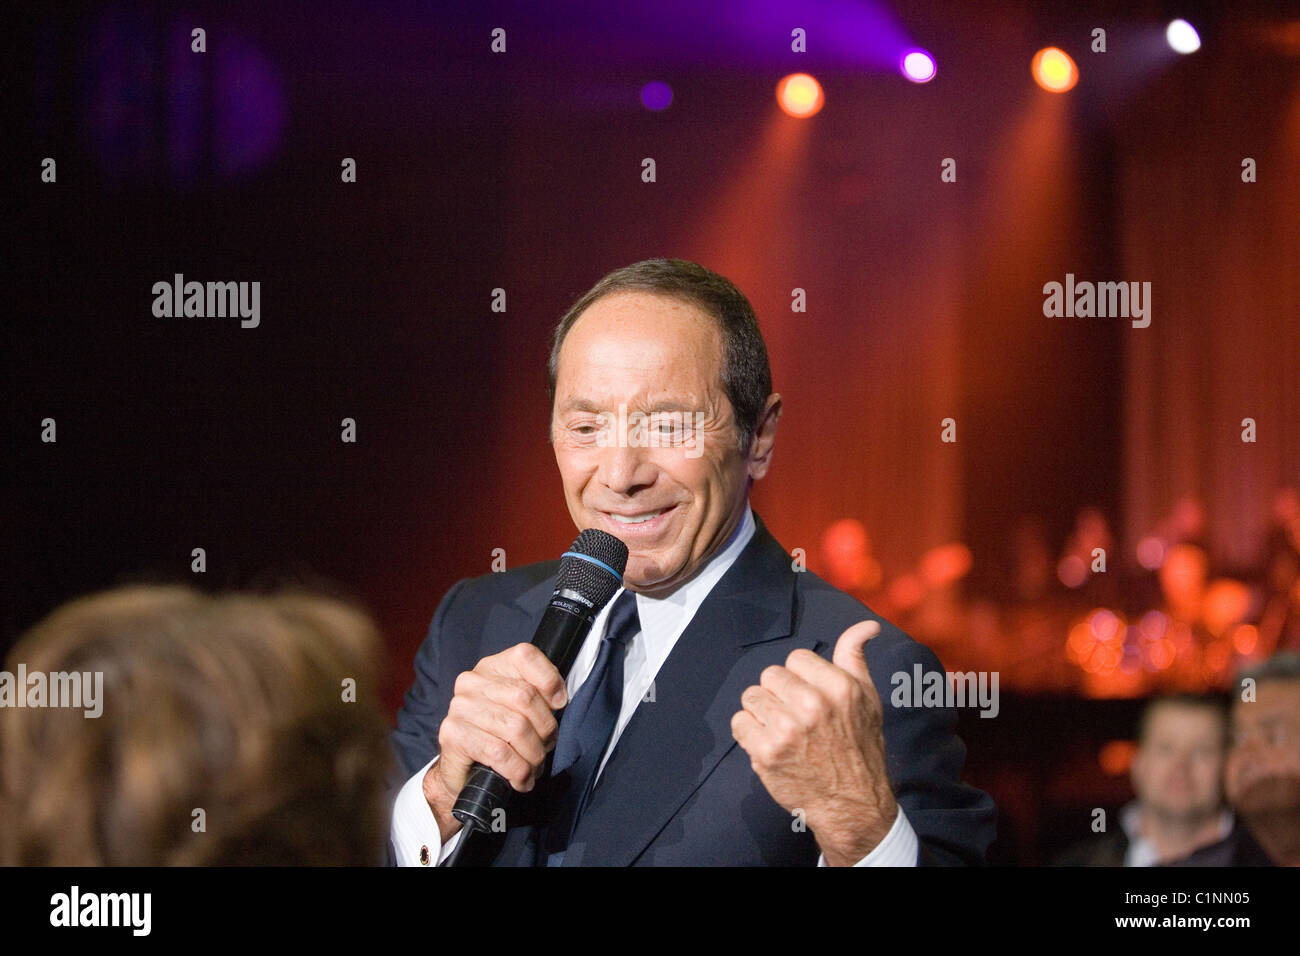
[391,260,996,865]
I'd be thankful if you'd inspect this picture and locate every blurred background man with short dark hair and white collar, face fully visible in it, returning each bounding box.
[1057,695,1232,866]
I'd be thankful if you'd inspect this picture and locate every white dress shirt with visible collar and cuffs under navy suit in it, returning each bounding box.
[391,506,919,866]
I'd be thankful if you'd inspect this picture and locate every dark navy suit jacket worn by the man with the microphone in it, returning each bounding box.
[393,515,997,866]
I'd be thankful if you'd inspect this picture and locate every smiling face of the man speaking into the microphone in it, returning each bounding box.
[551,291,780,594]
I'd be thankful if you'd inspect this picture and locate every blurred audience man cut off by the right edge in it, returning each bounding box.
[1178,652,1300,866]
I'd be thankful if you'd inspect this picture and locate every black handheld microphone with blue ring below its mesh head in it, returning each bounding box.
[449,528,628,837]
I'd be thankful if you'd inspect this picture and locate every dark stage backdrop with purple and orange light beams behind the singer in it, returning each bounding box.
[10,3,1300,864]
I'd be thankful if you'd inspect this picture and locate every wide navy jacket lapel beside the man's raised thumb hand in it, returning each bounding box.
[564,515,818,866]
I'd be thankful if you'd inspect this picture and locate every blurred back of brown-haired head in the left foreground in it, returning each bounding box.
[0,587,390,866]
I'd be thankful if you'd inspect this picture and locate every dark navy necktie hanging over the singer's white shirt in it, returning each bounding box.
[538,591,641,866]
